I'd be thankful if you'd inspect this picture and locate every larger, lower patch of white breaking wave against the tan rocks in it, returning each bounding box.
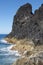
[0,45,21,56]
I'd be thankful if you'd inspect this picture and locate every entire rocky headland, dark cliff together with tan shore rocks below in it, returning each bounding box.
[5,3,43,65]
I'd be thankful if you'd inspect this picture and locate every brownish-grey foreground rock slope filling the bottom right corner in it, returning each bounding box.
[13,52,43,65]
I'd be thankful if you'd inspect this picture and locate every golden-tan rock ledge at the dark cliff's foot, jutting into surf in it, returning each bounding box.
[5,38,34,55]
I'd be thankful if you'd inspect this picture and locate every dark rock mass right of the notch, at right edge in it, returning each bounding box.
[32,4,43,44]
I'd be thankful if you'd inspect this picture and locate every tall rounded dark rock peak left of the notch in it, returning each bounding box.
[7,3,33,39]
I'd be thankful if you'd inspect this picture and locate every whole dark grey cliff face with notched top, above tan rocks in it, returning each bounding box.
[8,3,43,44]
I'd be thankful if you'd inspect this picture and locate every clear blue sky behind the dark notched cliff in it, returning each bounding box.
[0,0,43,34]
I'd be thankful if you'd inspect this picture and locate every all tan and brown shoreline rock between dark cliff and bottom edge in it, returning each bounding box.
[5,38,43,65]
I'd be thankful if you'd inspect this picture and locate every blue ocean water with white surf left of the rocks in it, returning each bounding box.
[0,34,19,65]
